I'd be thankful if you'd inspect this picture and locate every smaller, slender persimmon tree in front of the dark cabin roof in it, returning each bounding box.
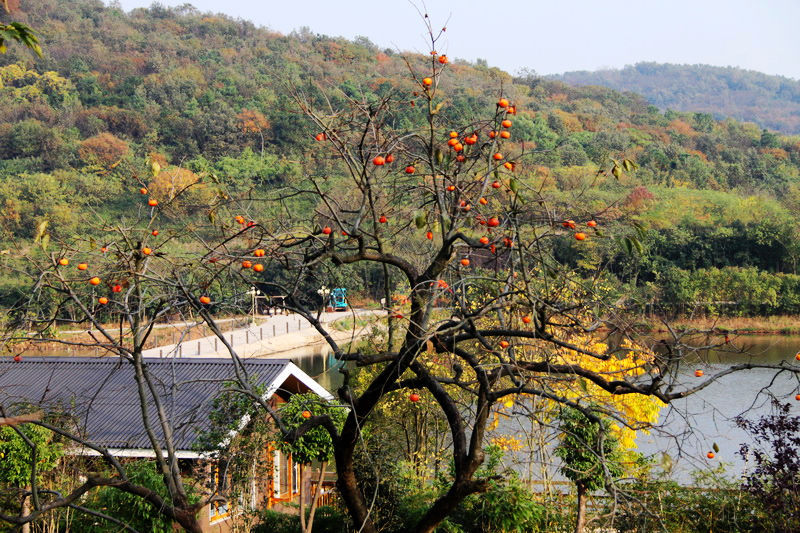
[0,178,260,531]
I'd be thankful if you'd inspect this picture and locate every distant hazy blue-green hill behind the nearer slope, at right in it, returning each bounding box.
[552,63,800,134]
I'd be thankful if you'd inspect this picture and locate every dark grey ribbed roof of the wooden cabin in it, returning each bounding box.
[0,357,290,450]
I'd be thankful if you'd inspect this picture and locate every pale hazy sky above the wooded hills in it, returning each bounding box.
[114,0,800,79]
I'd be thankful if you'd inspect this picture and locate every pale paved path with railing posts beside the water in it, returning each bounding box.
[142,309,385,358]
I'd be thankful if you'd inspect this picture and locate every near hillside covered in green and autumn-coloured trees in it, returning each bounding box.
[0,0,800,312]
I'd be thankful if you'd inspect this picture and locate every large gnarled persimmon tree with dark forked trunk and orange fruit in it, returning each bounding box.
[252,16,796,532]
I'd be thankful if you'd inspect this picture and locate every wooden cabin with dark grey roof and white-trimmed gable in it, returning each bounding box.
[0,357,332,532]
